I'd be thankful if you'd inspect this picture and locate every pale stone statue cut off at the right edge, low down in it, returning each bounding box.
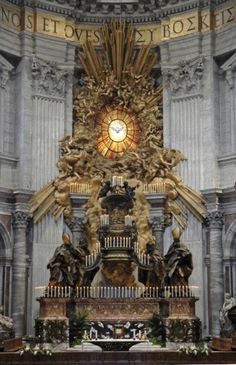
[220,293,236,337]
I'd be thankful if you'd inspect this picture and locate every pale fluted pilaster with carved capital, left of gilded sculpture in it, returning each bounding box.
[31,56,67,244]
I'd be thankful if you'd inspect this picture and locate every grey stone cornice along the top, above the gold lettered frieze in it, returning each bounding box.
[5,0,230,23]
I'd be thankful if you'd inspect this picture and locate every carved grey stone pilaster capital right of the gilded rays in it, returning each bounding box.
[162,57,204,96]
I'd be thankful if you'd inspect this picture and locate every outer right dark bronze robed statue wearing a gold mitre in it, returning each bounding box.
[164,227,193,286]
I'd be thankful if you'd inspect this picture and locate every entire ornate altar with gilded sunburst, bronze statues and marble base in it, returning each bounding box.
[31,22,206,341]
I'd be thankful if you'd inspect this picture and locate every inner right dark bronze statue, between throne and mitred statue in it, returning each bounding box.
[146,243,165,288]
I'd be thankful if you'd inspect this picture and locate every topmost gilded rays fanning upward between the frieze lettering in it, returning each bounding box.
[79,20,158,83]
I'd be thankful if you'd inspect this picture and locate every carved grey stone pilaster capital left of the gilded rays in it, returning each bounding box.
[32,56,69,98]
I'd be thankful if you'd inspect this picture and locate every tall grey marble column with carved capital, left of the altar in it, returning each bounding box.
[12,211,28,336]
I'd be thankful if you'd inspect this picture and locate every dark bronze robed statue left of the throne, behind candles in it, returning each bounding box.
[47,233,85,286]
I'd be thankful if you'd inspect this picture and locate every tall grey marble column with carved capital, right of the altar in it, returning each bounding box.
[206,210,224,336]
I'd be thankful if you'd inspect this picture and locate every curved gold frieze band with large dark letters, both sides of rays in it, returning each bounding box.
[0,2,236,45]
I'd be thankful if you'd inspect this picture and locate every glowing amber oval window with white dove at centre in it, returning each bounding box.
[95,105,140,159]
